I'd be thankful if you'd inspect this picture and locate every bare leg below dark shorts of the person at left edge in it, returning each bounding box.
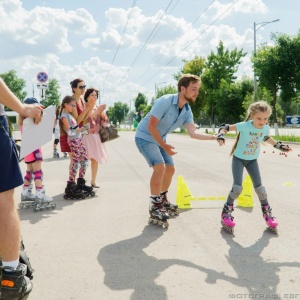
[0,190,21,261]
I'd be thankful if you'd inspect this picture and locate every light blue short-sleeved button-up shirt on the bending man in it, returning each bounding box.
[135,94,194,144]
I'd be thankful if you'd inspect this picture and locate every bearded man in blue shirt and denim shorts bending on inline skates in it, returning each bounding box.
[135,74,218,227]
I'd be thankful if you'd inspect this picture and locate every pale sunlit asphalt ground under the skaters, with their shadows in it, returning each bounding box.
[15,132,300,300]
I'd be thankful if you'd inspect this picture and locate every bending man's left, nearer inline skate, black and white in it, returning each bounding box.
[148,197,169,228]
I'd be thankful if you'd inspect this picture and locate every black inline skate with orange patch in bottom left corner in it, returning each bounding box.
[0,263,33,300]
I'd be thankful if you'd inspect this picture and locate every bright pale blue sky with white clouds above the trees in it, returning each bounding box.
[0,0,300,106]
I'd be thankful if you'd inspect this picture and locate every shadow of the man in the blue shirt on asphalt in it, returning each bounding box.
[98,225,225,300]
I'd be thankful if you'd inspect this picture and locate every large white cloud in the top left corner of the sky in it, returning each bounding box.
[0,0,97,59]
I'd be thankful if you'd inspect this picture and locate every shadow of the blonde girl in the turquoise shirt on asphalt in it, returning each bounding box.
[220,229,300,296]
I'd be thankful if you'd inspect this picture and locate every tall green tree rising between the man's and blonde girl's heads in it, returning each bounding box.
[202,41,247,124]
